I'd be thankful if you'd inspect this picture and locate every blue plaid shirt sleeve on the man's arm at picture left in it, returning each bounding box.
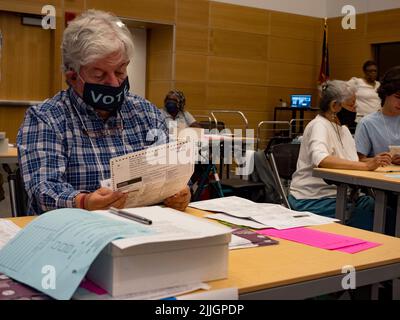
[17,107,79,214]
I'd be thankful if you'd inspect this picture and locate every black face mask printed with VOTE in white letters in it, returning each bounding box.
[83,77,129,112]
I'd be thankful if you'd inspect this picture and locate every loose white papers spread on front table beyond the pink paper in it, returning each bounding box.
[189,196,339,230]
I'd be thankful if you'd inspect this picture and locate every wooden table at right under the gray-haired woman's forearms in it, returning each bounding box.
[313,166,400,237]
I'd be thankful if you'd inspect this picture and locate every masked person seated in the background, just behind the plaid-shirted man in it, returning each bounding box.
[161,90,200,129]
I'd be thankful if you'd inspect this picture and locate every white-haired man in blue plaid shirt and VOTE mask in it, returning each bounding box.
[17,10,190,214]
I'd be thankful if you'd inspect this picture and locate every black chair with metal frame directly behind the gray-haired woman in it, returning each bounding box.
[267,143,300,209]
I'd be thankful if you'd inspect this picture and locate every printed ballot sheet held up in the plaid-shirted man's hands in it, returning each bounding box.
[110,141,195,208]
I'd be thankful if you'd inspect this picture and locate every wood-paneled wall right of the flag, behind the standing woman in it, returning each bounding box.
[328,9,400,80]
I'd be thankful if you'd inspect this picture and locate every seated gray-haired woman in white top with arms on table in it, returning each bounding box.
[288,80,390,230]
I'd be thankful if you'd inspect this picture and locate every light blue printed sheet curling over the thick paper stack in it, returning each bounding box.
[0,209,154,299]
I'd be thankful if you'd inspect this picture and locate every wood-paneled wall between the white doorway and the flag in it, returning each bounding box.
[174,0,322,128]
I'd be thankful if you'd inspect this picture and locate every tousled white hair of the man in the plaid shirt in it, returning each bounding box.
[61,10,133,72]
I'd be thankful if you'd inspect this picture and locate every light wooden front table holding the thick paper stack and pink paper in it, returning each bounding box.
[7,208,400,299]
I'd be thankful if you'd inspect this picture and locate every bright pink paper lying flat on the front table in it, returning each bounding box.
[257,228,380,253]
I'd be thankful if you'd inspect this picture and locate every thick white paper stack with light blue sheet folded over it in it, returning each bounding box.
[0,207,231,299]
